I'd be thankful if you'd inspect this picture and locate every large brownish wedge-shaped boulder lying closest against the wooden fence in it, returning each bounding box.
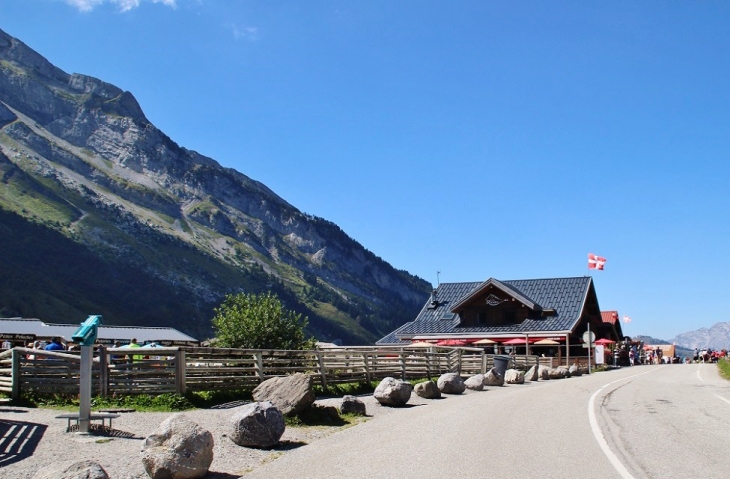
[253,373,317,416]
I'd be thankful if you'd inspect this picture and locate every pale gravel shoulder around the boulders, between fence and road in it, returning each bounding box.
[0,394,428,479]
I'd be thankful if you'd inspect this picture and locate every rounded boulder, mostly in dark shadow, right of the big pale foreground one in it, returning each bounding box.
[228,401,286,447]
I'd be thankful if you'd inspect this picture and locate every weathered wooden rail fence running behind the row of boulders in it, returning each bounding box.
[0,347,538,399]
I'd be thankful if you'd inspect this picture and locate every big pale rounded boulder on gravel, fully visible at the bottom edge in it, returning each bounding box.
[142,414,213,479]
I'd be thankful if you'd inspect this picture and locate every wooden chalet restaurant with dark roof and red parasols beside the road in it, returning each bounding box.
[376,276,621,360]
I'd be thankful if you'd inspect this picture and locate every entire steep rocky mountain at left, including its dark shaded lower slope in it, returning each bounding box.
[0,30,431,344]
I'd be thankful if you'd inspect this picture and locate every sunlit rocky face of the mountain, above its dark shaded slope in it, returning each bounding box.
[0,31,430,341]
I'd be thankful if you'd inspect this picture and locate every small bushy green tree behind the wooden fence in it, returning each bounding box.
[213,292,315,349]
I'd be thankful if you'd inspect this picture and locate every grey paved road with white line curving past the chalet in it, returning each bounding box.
[245,365,730,479]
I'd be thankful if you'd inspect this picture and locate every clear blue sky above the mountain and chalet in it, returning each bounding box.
[0,0,730,339]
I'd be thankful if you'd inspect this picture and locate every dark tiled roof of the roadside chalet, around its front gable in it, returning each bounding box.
[378,276,592,344]
